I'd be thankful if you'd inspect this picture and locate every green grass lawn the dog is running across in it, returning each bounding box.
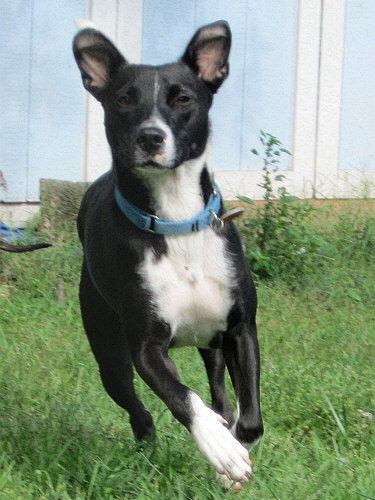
[0,208,375,500]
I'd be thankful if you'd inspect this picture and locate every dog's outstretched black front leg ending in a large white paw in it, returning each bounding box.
[132,335,252,481]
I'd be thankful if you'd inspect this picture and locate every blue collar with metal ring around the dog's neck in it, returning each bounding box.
[115,183,222,235]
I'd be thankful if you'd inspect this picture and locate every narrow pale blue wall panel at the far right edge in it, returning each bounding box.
[339,0,375,170]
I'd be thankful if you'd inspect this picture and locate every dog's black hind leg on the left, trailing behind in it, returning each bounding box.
[80,264,155,440]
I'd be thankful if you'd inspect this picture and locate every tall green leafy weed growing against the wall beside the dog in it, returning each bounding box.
[240,131,323,278]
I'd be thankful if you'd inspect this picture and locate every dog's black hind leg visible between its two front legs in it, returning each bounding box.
[198,349,233,426]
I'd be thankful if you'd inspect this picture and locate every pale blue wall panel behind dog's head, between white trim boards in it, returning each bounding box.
[142,0,298,170]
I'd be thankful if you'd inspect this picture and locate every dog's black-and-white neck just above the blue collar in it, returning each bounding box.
[114,151,211,221]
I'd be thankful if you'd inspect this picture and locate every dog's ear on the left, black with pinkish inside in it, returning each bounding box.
[73,28,126,100]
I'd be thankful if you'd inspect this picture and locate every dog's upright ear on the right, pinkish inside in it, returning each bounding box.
[181,21,232,92]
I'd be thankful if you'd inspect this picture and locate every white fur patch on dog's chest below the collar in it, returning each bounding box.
[141,229,233,347]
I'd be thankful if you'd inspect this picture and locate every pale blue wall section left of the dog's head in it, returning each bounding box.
[0,0,85,201]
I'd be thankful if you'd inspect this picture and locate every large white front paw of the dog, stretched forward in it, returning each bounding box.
[190,393,252,482]
